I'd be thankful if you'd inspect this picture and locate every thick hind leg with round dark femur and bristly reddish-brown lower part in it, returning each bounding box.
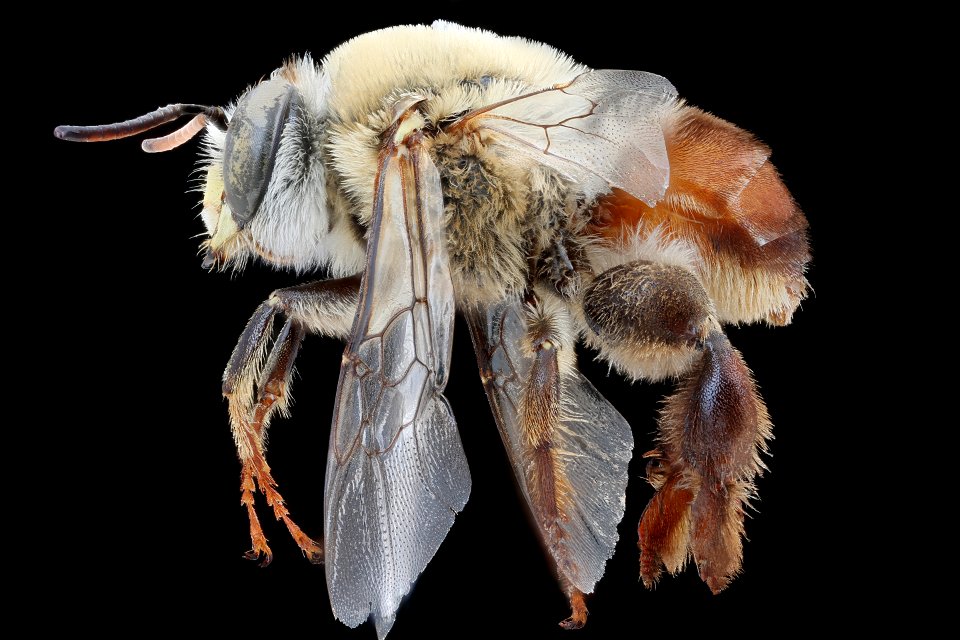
[584,261,771,593]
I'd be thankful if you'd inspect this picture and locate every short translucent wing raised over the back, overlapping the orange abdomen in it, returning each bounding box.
[461,69,677,206]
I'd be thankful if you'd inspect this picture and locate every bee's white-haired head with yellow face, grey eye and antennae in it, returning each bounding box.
[55,56,362,272]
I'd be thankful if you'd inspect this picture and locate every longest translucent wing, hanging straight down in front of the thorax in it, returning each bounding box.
[324,145,470,638]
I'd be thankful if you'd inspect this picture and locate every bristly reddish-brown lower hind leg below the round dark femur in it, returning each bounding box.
[639,330,770,593]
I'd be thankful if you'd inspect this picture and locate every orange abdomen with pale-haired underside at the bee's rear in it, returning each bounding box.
[591,107,810,324]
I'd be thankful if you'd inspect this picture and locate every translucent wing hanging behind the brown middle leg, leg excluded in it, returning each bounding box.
[467,303,633,593]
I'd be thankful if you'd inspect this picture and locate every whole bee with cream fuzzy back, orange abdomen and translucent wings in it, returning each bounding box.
[55,22,810,638]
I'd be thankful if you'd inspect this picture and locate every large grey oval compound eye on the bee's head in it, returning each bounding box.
[223,78,300,229]
